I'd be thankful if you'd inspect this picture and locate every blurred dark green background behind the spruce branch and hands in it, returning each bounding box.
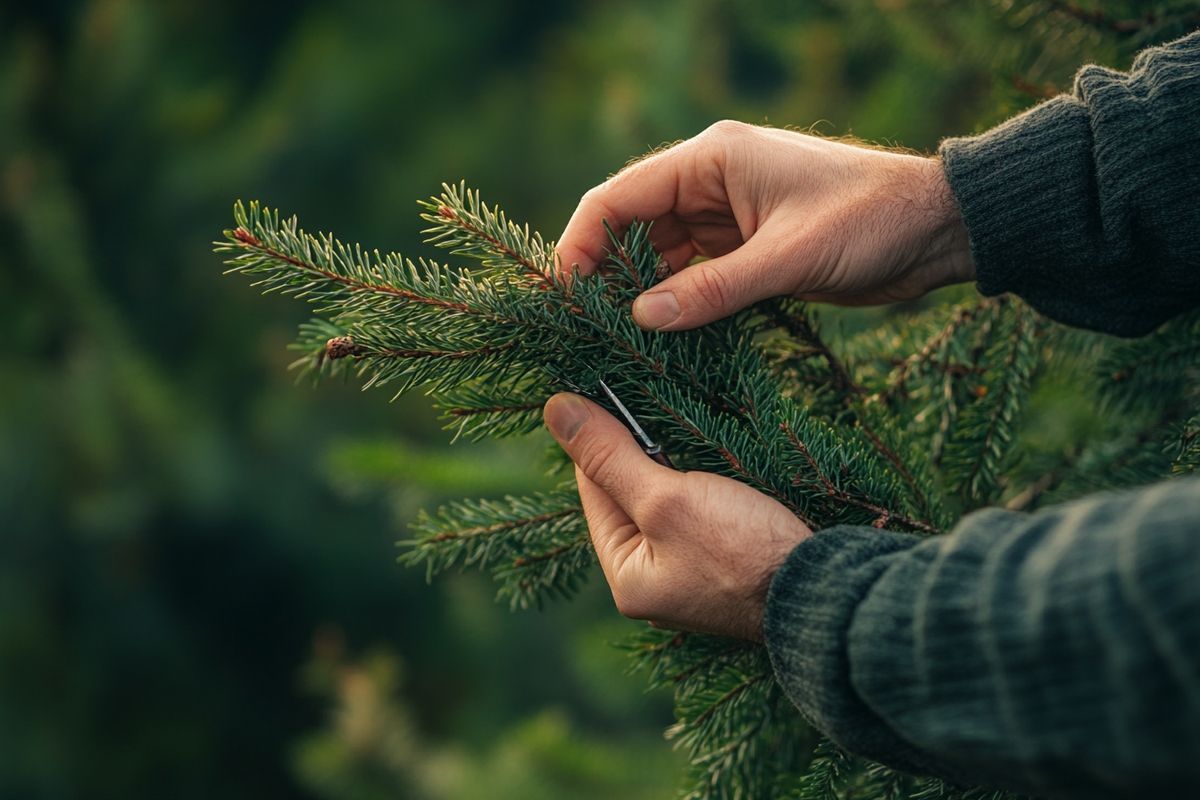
[0,0,1142,799]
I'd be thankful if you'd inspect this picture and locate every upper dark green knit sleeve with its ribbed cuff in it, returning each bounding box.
[941,32,1200,336]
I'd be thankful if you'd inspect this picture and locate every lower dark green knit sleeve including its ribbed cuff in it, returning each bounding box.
[764,479,1200,799]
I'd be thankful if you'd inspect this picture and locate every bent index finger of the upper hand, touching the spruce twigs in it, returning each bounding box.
[554,145,680,275]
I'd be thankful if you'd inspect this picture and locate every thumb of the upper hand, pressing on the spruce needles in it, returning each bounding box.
[632,237,788,331]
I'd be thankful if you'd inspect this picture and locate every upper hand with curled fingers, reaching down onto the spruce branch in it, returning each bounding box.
[557,121,974,331]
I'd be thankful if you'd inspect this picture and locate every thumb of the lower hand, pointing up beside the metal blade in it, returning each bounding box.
[542,392,678,516]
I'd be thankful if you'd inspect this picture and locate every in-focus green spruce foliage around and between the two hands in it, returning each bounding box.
[217,172,1200,798]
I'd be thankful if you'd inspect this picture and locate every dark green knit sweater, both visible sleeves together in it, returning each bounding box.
[764,28,1200,799]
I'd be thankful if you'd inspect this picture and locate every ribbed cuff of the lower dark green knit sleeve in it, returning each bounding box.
[763,525,924,769]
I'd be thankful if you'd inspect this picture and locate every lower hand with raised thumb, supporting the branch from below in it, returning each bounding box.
[545,393,812,640]
